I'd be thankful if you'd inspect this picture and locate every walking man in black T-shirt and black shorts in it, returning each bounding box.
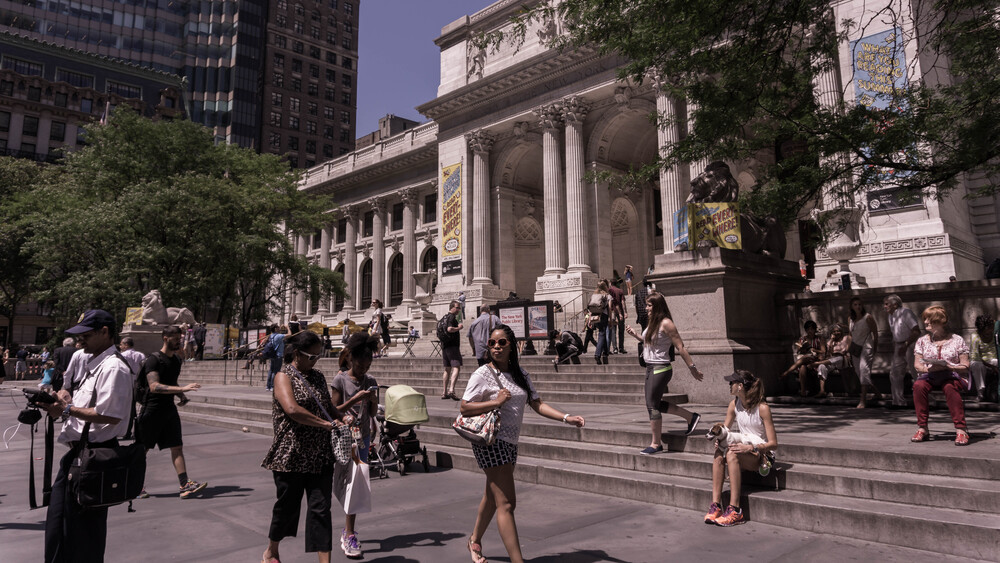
[136,326,208,498]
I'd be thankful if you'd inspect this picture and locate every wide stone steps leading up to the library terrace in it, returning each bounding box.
[182,355,1000,561]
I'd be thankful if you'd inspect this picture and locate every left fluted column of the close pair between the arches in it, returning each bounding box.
[533,104,566,276]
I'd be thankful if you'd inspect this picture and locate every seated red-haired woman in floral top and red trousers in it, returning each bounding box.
[911,307,969,446]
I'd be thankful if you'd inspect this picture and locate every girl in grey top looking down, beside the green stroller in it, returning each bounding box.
[330,332,379,558]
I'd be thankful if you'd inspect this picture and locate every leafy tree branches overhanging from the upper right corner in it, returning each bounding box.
[476,0,1000,231]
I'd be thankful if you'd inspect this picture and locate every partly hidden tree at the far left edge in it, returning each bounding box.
[0,156,45,346]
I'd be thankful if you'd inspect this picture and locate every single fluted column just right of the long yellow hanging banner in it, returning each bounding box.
[465,130,494,284]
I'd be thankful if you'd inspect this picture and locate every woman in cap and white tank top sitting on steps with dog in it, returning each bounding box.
[705,369,778,526]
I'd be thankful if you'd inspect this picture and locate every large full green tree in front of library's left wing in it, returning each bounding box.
[22,108,344,326]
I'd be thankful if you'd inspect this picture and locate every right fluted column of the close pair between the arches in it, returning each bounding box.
[562,96,590,272]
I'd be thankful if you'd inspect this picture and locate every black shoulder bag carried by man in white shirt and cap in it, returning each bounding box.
[66,363,146,508]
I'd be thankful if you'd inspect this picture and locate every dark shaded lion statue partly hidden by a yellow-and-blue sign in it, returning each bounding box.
[687,160,788,259]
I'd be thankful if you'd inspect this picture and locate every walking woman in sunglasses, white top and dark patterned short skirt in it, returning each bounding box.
[460,325,584,563]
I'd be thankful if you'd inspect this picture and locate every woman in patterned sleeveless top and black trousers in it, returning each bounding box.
[261,331,350,563]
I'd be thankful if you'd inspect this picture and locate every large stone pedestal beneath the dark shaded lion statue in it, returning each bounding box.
[649,248,802,404]
